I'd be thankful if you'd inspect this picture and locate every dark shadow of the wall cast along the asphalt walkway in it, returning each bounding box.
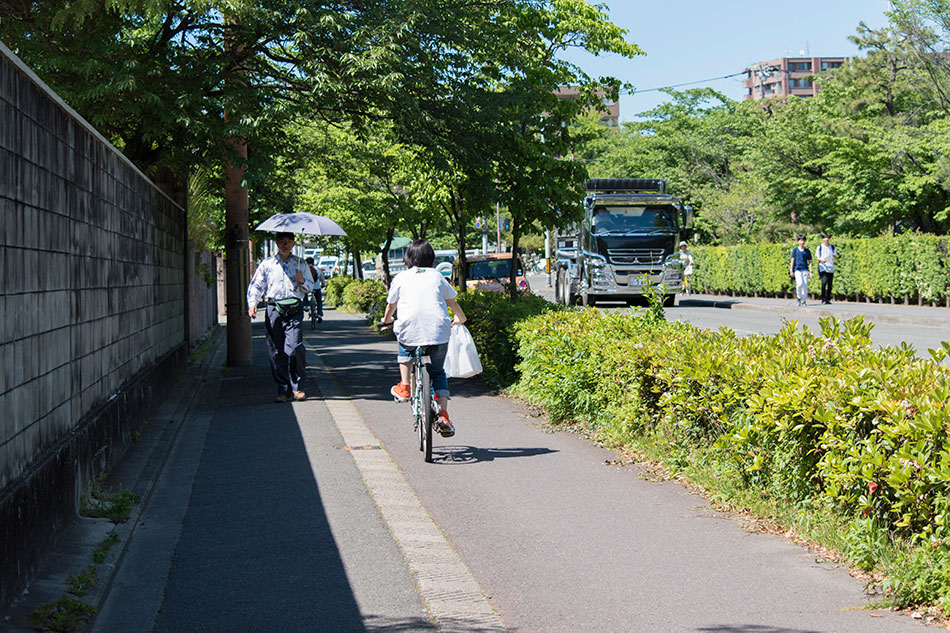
[154,323,370,633]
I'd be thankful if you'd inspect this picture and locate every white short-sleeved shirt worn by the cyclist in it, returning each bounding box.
[386,267,458,347]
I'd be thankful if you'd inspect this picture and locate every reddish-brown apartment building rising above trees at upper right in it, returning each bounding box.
[742,57,848,100]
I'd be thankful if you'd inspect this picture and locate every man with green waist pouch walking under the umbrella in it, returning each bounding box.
[247,233,313,402]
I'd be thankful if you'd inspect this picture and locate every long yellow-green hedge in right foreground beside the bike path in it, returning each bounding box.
[515,310,950,608]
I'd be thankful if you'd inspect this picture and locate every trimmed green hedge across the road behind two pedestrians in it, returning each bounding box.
[690,233,950,305]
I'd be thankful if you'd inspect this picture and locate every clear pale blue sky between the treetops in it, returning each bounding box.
[564,0,888,121]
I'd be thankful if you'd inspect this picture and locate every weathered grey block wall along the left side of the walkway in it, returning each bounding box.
[0,44,193,608]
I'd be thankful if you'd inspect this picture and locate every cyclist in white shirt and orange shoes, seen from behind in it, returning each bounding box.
[382,240,465,437]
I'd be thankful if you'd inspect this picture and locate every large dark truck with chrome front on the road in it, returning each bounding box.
[553,178,693,306]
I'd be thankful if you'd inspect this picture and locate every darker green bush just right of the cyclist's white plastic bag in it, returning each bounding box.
[457,290,561,387]
